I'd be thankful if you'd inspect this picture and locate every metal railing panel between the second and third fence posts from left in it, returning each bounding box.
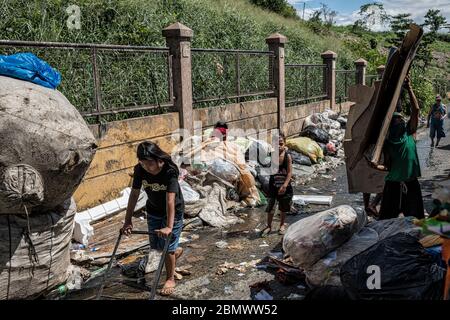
[285,64,328,107]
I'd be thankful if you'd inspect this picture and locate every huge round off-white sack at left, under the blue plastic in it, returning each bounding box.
[0,76,96,214]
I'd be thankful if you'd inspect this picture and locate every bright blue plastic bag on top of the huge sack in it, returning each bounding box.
[0,52,61,89]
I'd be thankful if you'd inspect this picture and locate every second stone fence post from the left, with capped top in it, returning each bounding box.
[266,33,287,130]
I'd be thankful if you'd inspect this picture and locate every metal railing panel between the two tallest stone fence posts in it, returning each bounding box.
[191,48,275,108]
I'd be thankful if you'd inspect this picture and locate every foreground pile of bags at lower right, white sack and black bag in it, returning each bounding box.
[283,205,445,300]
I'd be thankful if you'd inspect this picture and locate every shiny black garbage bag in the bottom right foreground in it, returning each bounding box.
[340,233,445,300]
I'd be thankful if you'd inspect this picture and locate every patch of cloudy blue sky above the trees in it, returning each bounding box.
[288,0,450,31]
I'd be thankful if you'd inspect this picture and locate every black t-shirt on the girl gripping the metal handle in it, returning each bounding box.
[133,164,184,220]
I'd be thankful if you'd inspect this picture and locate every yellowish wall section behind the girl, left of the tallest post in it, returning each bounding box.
[74,113,179,211]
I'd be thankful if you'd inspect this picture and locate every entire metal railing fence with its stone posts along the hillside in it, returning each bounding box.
[0,23,376,132]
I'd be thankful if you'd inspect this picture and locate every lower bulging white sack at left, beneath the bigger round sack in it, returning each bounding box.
[0,199,76,300]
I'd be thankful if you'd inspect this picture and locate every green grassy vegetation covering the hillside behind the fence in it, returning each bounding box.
[0,0,450,120]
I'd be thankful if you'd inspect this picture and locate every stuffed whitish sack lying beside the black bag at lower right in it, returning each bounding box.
[283,205,367,268]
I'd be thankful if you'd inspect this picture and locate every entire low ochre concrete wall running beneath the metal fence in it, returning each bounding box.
[75,98,352,211]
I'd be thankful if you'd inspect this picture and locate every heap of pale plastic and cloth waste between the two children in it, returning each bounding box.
[175,137,268,228]
